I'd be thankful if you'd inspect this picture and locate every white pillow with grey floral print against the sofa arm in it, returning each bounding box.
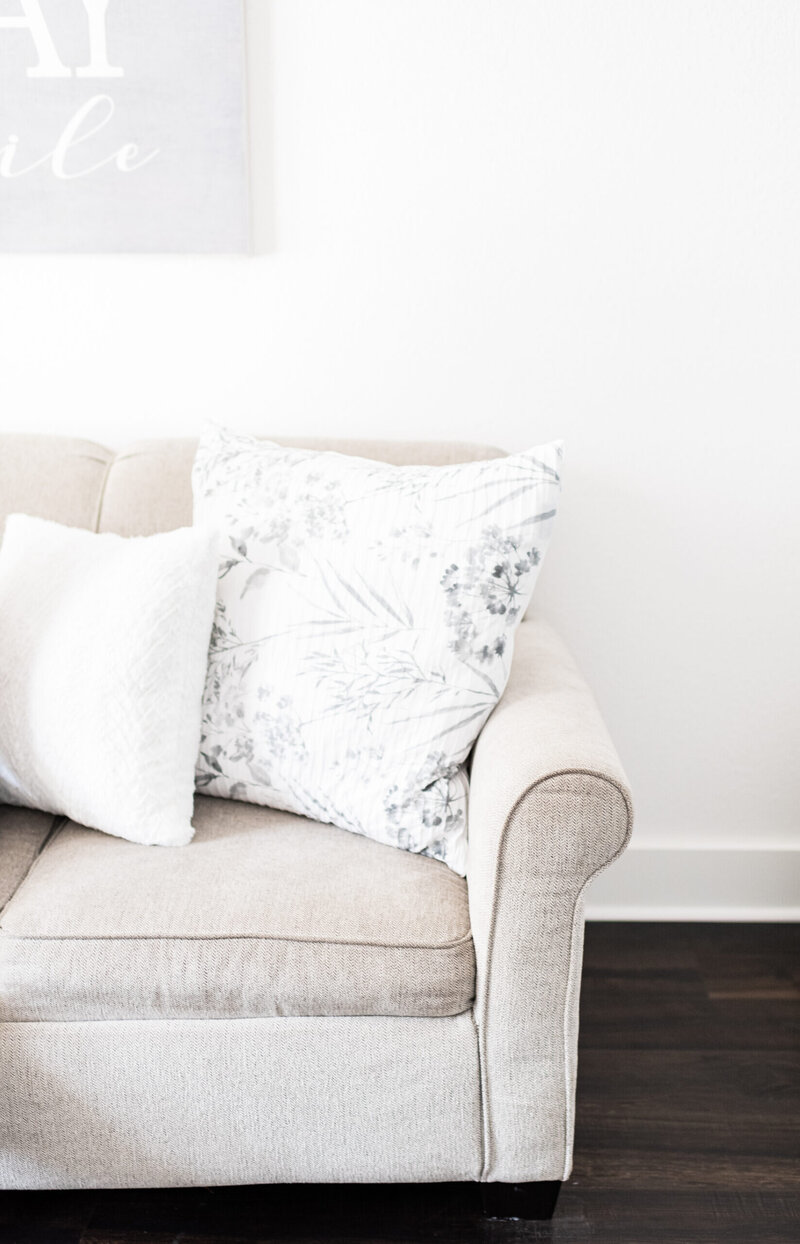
[193,428,561,875]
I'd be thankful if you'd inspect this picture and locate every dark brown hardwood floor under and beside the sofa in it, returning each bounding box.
[0,924,800,1244]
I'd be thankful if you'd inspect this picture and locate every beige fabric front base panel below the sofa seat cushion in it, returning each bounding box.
[0,1015,480,1188]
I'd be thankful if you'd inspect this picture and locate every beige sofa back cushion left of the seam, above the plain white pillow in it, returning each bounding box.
[0,434,112,536]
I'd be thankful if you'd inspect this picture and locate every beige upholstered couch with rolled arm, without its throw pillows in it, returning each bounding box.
[0,437,631,1215]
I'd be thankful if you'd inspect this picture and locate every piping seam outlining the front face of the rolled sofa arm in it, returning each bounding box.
[475,769,633,1182]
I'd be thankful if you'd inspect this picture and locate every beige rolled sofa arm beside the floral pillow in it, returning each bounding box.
[467,620,632,1183]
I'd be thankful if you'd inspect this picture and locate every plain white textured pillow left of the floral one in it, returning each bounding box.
[0,514,218,846]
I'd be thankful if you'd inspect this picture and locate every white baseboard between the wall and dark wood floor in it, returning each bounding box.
[586,847,800,922]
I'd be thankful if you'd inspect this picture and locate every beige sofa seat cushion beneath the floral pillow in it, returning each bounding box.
[0,797,475,1021]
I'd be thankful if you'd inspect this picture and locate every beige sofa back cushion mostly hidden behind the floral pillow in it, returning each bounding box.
[98,437,503,536]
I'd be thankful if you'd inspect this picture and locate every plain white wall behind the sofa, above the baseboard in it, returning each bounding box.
[0,0,800,895]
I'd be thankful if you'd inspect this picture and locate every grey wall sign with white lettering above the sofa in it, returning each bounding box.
[0,0,249,253]
